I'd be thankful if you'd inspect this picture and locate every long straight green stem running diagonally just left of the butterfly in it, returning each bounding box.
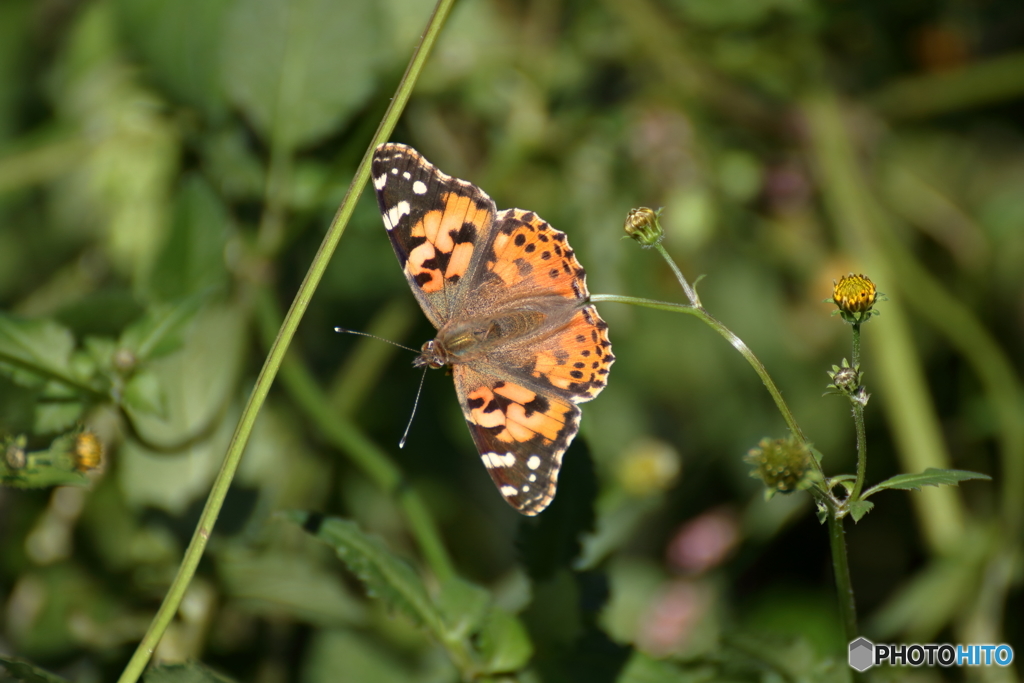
[111,0,455,683]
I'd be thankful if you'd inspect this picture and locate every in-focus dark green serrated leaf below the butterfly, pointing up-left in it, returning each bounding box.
[285,512,444,636]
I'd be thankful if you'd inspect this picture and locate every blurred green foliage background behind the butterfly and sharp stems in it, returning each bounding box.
[0,0,1024,683]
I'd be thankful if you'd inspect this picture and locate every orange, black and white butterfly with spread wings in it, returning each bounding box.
[371,142,615,515]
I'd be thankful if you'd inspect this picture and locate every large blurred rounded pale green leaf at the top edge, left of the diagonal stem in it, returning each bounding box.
[223,0,385,151]
